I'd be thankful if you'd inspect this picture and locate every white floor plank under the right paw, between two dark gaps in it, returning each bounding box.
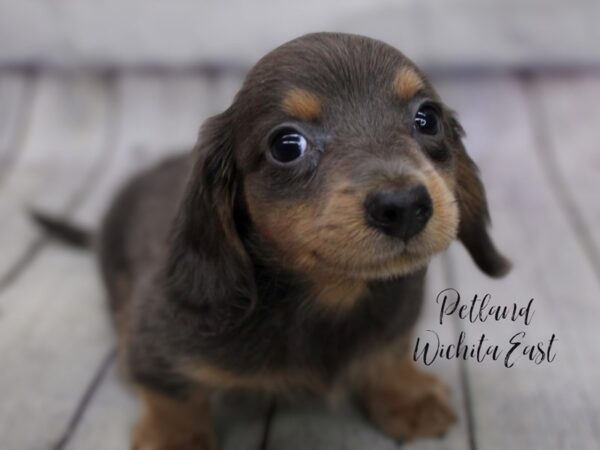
[267,258,468,450]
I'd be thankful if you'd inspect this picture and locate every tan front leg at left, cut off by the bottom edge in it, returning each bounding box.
[132,388,216,450]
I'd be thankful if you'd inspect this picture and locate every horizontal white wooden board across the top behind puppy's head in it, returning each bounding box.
[0,0,600,67]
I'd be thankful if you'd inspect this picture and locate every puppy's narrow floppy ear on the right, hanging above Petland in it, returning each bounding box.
[453,119,511,277]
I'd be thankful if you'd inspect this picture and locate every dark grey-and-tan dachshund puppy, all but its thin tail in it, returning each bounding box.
[98,33,508,450]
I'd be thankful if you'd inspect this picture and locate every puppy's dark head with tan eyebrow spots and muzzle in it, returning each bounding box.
[175,33,508,306]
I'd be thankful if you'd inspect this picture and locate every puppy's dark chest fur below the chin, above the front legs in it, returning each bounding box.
[203,275,423,382]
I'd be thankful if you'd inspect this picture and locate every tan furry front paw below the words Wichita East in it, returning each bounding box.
[367,371,456,440]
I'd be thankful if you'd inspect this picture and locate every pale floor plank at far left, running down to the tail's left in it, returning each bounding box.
[0,75,110,279]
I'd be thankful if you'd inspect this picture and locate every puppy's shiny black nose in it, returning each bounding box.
[365,185,433,240]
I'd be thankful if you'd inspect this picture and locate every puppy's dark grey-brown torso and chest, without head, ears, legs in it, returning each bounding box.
[99,155,425,395]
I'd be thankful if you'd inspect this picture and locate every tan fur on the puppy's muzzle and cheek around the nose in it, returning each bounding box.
[247,173,453,282]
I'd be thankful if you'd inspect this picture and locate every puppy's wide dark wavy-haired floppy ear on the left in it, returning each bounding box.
[166,110,255,332]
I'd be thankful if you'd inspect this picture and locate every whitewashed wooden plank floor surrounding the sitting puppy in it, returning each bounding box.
[0,73,600,450]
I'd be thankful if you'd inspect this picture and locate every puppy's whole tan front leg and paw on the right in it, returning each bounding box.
[351,344,456,440]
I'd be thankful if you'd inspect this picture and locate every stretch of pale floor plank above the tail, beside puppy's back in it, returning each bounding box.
[75,74,210,228]
